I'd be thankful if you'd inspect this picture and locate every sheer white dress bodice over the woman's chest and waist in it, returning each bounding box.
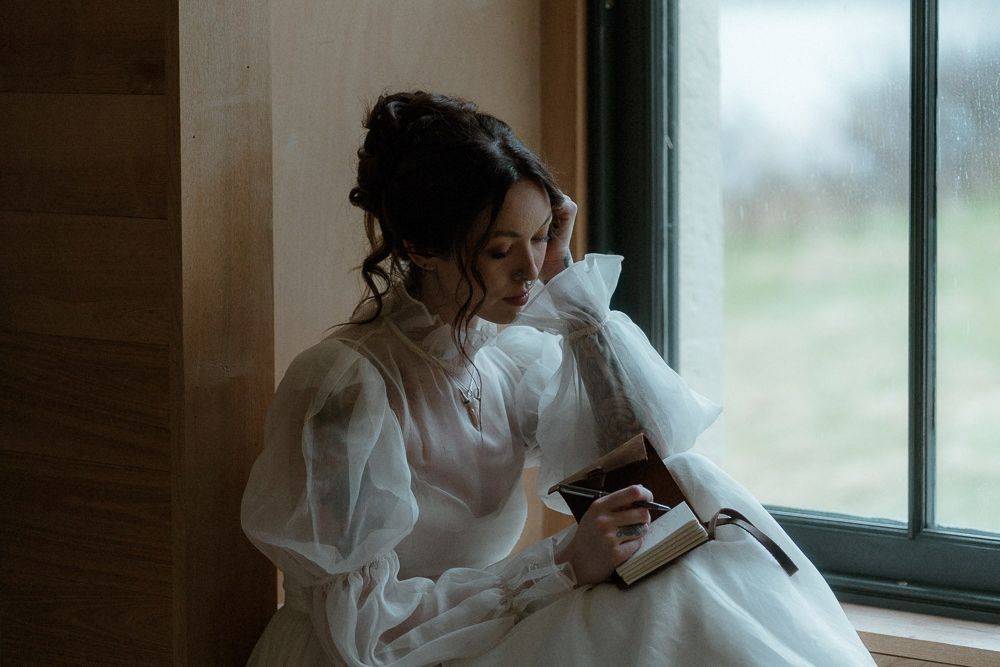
[328,287,527,578]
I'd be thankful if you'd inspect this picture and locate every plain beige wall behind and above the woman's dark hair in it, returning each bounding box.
[271,0,541,378]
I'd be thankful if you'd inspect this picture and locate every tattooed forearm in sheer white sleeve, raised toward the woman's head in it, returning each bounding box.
[519,255,719,464]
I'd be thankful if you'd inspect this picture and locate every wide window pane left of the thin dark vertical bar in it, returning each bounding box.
[719,0,910,520]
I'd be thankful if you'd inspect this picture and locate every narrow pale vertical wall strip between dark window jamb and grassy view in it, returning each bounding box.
[675,0,725,461]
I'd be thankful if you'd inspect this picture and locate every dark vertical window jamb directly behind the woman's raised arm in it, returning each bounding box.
[587,0,680,369]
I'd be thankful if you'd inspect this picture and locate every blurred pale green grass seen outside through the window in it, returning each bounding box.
[725,201,1000,531]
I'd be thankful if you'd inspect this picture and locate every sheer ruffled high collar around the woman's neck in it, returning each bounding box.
[382,283,497,372]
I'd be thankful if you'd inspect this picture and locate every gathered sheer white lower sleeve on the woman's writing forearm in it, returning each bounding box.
[309,540,576,667]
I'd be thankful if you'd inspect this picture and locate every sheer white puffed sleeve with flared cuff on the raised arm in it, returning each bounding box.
[498,254,721,512]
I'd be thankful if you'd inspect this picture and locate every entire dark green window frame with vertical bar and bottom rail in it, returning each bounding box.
[587,0,1000,623]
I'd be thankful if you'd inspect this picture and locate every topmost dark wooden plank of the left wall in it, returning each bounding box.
[0,0,169,93]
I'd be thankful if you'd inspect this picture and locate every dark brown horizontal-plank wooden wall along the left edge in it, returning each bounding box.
[0,0,180,665]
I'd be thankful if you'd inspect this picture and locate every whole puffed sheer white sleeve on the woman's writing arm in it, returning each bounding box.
[242,339,575,667]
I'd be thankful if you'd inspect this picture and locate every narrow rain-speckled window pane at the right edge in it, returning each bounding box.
[937,0,1000,531]
